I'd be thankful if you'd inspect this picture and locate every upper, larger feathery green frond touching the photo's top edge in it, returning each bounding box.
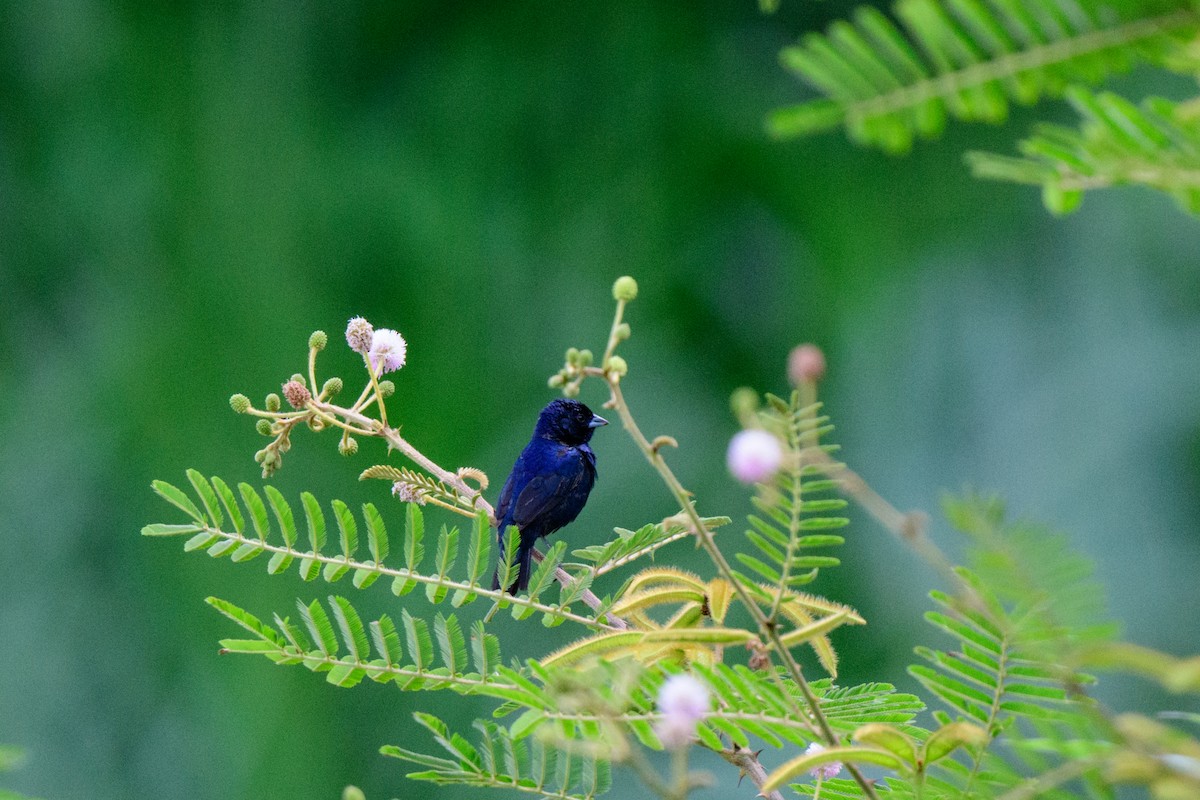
[769,0,1200,152]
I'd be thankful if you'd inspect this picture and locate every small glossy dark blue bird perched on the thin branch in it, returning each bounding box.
[492,399,608,595]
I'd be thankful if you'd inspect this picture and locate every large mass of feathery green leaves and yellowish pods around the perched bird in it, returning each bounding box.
[143,292,1200,800]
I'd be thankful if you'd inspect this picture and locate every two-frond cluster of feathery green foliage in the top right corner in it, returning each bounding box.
[768,0,1200,215]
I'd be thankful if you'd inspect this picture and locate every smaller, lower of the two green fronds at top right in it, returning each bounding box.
[967,89,1200,213]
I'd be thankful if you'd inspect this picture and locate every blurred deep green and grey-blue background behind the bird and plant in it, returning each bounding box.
[0,0,1200,800]
